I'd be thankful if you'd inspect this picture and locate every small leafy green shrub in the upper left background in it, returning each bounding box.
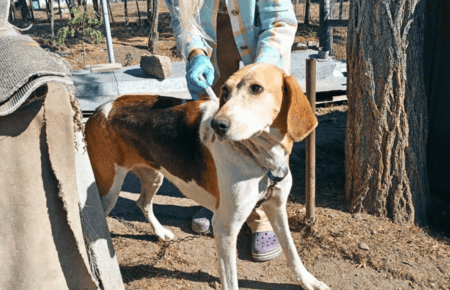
[56,6,104,63]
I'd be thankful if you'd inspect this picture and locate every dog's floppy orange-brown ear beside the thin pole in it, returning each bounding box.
[284,76,318,142]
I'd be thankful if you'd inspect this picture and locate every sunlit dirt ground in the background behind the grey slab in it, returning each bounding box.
[13,1,348,70]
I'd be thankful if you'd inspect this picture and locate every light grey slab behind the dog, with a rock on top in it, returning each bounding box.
[72,49,347,111]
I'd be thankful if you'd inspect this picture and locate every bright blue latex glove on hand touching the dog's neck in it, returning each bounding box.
[186,54,214,100]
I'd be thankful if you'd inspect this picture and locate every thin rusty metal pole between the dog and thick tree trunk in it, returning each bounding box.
[305,58,316,219]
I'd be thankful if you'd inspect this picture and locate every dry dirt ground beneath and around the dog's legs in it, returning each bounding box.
[100,105,450,290]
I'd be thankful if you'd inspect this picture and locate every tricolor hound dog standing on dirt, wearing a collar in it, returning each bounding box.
[86,63,329,290]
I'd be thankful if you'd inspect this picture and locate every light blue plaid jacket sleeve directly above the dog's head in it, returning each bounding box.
[255,0,298,66]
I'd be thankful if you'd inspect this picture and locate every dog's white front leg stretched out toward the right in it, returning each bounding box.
[262,173,330,290]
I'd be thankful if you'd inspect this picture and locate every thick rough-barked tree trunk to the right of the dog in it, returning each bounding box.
[345,0,429,225]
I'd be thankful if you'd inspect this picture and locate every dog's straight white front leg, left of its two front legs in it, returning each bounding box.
[212,205,251,290]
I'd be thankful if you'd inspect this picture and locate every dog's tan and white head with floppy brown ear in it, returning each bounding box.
[211,63,317,142]
